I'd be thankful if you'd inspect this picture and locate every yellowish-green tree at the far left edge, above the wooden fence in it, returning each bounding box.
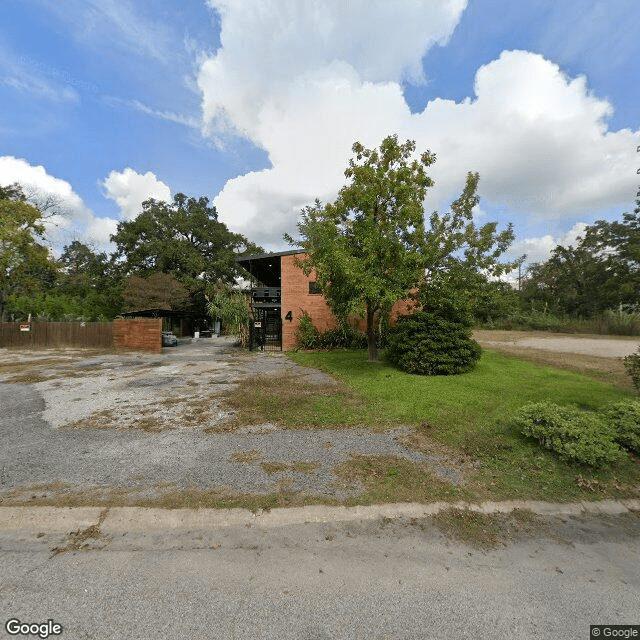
[0,184,56,319]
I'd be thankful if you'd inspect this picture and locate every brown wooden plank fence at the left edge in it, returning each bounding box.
[0,322,113,348]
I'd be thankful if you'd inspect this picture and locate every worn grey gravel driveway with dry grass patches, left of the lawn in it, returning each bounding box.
[0,338,459,505]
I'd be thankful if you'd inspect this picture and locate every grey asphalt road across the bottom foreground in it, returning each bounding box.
[0,514,640,640]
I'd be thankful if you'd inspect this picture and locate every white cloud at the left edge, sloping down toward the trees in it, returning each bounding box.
[0,156,117,254]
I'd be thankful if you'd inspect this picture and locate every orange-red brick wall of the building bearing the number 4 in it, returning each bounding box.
[280,254,412,351]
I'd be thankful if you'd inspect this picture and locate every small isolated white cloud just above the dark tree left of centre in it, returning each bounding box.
[102,167,171,220]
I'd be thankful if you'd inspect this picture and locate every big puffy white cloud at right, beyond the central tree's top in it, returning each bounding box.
[416,51,640,219]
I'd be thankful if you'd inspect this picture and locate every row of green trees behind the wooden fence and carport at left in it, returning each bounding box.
[0,184,262,321]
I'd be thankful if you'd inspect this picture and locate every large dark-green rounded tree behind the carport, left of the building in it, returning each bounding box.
[111,193,259,312]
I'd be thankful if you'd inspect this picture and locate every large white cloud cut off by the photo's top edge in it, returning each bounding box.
[198,0,467,141]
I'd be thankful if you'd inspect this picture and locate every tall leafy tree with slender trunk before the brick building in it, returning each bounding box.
[285,136,435,361]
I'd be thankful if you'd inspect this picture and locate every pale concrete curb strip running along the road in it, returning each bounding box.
[0,499,640,534]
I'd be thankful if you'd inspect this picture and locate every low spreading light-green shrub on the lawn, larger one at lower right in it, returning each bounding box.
[514,402,624,467]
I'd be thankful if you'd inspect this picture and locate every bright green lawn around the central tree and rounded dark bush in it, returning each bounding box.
[288,351,633,446]
